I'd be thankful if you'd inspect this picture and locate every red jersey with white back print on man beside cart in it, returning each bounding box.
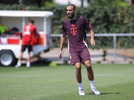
[22,24,36,45]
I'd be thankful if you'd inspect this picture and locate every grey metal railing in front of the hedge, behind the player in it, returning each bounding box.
[51,33,134,64]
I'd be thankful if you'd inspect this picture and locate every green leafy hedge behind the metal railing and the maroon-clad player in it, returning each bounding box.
[0,4,134,49]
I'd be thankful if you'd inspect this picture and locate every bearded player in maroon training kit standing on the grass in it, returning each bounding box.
[58,4,100,95]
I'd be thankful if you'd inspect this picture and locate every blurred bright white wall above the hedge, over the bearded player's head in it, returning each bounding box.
[54,0,88,7]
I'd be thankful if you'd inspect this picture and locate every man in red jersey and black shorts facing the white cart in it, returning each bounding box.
[15,20,37,68]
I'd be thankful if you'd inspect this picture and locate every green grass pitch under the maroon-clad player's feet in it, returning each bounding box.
[0,64,134,100]
